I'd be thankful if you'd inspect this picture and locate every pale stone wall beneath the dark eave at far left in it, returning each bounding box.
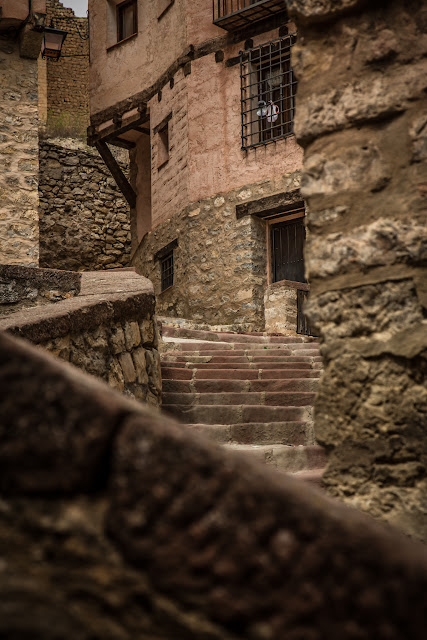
[0,35,39,266]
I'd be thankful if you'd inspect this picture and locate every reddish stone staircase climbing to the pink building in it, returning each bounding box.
[162,325,325,483]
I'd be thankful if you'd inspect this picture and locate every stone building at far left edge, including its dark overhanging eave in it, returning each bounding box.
[0,0,45,265]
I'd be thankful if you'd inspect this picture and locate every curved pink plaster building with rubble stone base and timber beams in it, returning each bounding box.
[89,0,308,334]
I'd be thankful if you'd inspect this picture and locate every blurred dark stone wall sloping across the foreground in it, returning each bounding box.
[0,330,427,640]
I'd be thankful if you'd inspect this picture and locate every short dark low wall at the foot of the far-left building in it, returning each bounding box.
[0,264,81,318]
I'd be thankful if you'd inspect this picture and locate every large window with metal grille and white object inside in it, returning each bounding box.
[240,33,297,149]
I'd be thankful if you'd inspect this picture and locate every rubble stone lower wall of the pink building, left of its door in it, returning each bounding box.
[132,172,299,330]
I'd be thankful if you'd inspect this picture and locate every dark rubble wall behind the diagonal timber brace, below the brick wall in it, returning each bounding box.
[39,140,131,270]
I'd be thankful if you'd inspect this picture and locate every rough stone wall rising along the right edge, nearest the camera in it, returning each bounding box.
[288,0,427,539]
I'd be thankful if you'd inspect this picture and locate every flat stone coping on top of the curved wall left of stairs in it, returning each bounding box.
[0,271,155,343]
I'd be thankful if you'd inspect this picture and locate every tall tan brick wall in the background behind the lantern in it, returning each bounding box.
[46,0,89,130]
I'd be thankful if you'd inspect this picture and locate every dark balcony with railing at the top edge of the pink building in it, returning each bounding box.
[213,0,286,31]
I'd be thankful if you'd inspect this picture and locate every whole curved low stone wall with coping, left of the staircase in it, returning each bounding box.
[0,271,162,406]
